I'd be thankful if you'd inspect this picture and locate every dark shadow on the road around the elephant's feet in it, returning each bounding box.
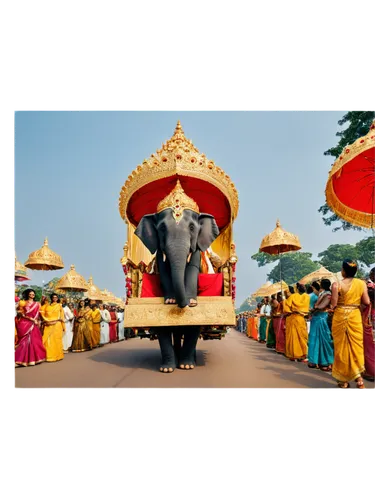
[90,348,206,371]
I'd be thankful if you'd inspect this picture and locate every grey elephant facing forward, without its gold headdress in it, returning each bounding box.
[135,208,220,373]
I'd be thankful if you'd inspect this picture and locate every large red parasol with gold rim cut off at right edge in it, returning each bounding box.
[326,120,375,229]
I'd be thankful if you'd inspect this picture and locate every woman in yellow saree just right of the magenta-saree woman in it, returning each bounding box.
[40,293,65,363]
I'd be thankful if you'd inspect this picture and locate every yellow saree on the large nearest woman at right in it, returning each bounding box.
[332,278,365,382]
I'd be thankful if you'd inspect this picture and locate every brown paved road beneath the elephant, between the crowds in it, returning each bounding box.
[14,329,375,391]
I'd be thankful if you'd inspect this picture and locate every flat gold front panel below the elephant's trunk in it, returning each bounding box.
[124,297,236,328]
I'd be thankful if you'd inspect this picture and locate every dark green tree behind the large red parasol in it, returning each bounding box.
[319,109,375,232]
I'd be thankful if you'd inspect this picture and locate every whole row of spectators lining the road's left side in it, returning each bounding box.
[12,288,129,366]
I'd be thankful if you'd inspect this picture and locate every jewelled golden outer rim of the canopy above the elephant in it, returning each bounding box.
[119,122,239,224]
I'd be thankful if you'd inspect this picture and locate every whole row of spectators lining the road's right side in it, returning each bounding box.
[237,259,375,391]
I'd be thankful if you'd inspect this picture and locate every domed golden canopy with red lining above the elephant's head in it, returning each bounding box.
[119,122,239,230]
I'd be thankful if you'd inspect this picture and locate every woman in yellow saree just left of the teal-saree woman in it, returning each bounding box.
[284,283,310,361]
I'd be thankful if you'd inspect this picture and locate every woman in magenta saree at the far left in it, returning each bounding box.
[12,288,46,366]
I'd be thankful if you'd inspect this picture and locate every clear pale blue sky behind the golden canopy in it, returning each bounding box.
[14,110,370,306]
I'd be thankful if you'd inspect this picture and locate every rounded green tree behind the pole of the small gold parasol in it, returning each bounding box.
[267,252,319,284]
